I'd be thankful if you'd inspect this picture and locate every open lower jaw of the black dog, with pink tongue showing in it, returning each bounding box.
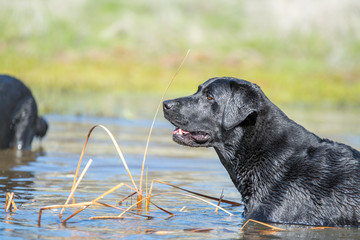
[173,128,211,147]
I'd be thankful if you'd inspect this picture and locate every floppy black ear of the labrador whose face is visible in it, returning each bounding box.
[222,82,259,130]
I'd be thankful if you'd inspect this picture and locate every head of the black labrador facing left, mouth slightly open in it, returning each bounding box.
[163,77,262,147]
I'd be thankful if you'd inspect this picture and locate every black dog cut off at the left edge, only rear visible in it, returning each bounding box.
[0,75,48,150]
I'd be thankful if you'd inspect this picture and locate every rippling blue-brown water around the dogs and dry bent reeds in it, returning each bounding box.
[0,109,360,239]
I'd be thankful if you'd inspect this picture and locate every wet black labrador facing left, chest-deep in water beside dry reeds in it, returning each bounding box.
[163,77,360,226]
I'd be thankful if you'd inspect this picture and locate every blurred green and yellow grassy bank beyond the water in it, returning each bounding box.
[0,0,360,117]
